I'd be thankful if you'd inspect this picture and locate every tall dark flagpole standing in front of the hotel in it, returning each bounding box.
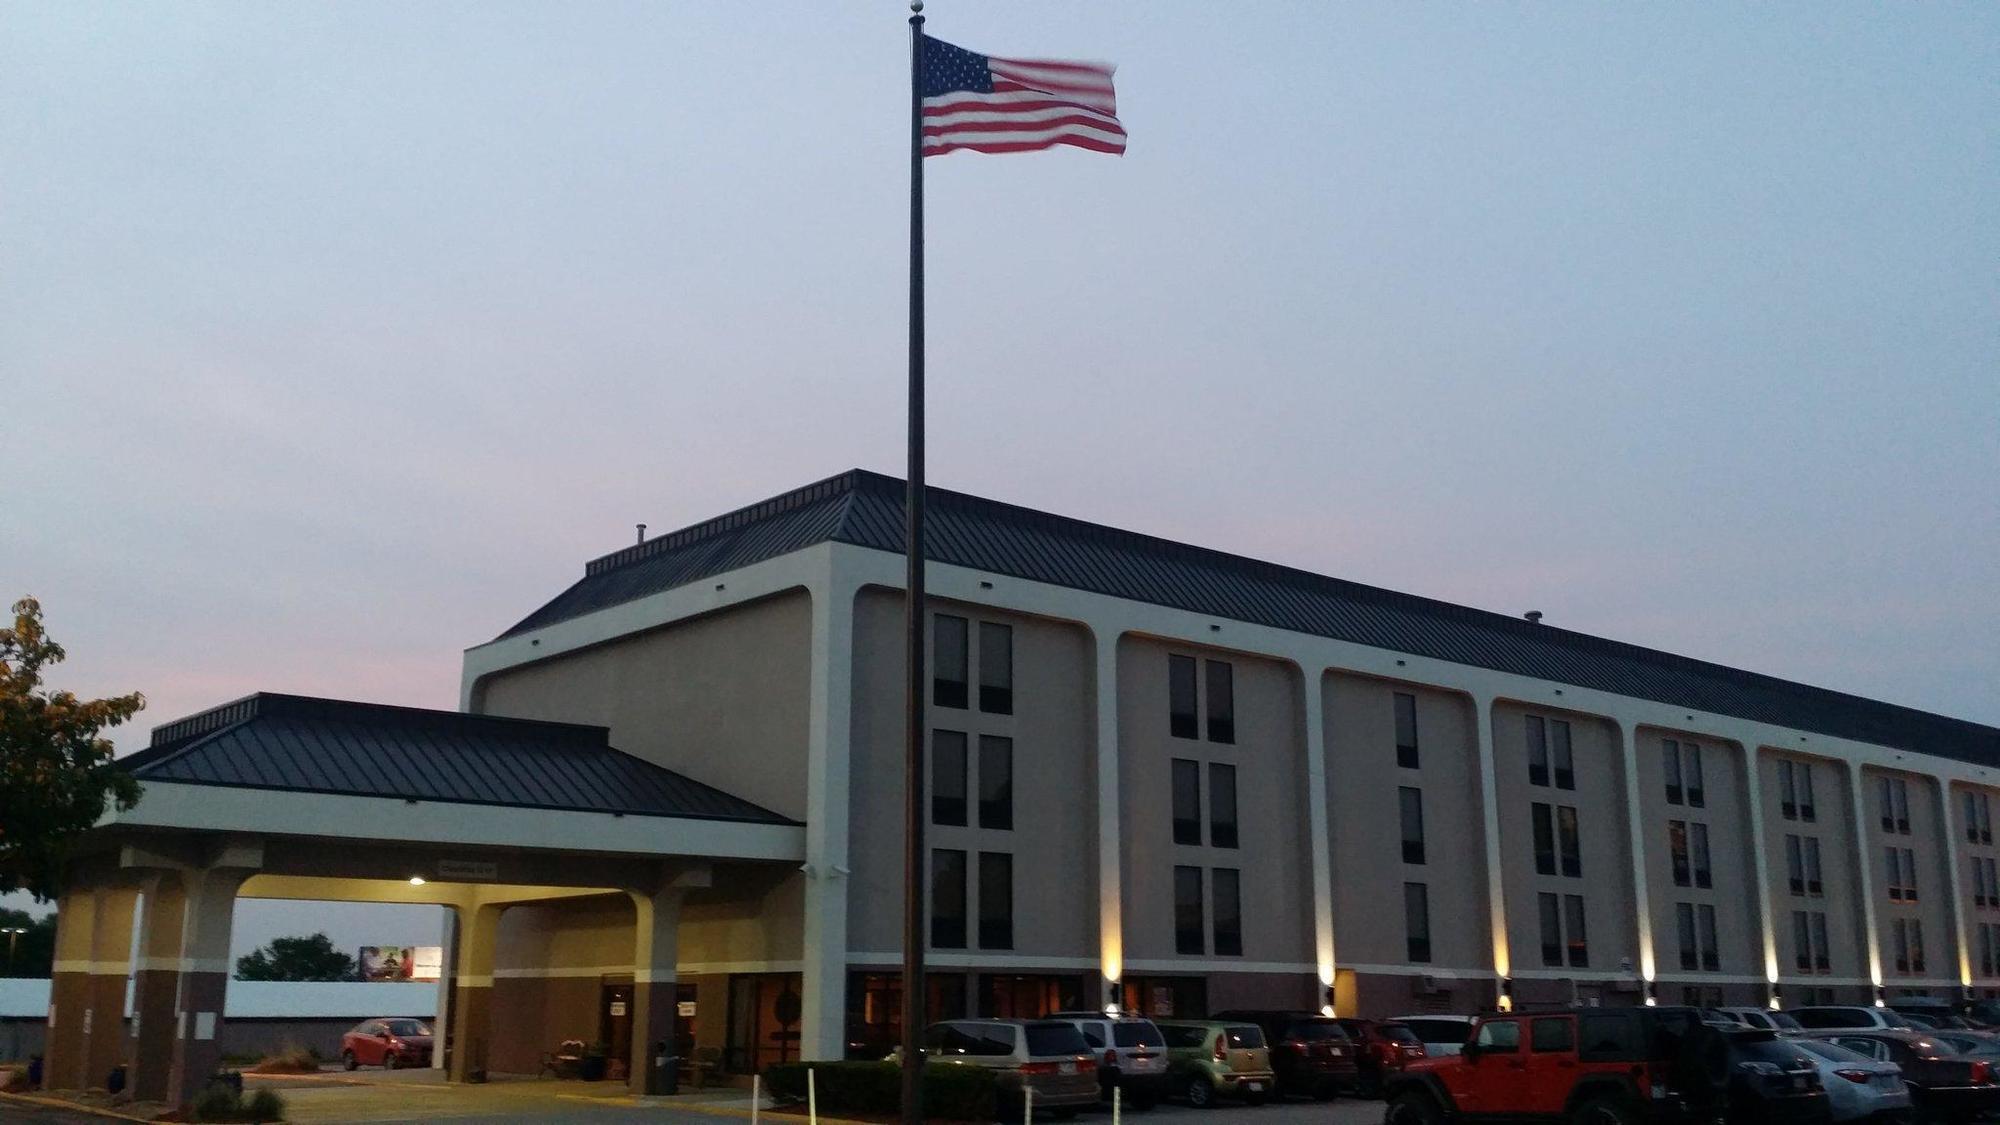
[902,0,926,1125]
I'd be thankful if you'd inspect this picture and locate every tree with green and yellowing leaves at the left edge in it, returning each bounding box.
[0,599,146,901]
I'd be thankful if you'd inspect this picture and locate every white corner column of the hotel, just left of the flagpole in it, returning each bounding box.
[798,550,856,1059]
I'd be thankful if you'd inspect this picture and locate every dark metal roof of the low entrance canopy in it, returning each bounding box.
[120,693,794,825]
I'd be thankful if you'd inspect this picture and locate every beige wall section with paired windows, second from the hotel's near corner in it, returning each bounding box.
[1118,637,1314,971]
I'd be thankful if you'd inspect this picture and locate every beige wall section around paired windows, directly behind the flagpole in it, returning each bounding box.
[848,589,1098,957]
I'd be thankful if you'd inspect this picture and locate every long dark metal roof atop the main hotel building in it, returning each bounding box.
[504,468,2000,765]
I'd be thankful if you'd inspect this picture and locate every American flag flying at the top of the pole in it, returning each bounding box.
[922,36,1126,156]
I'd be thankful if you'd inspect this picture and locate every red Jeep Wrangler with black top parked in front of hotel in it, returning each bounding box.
[1384,1007,1730,1125]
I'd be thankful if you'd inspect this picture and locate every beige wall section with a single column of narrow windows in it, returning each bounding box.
[1322,673,1492,968]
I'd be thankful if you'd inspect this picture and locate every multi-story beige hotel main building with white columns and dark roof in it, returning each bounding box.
[43,470,2000,1096]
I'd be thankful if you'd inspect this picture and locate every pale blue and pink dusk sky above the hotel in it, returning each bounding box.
[0,0,2000,947]
